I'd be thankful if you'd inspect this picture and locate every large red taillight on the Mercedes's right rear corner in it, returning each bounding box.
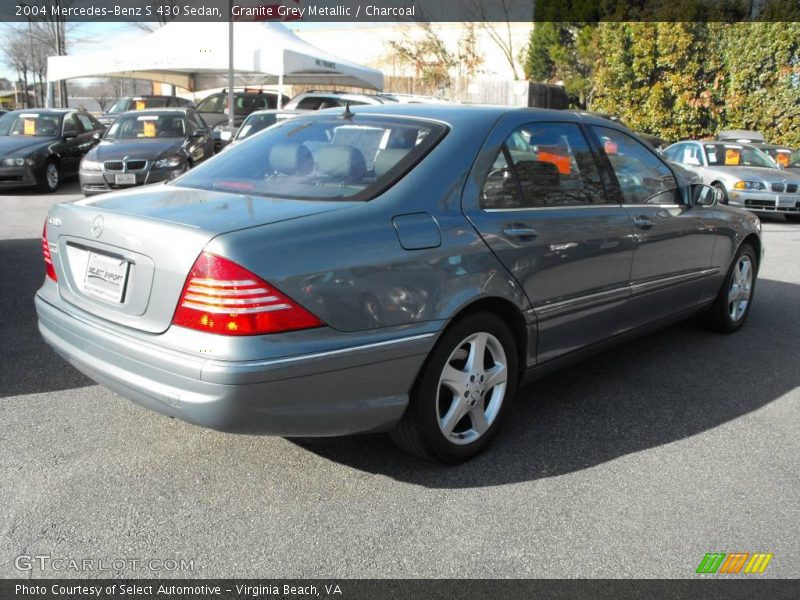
[172,252,322,335]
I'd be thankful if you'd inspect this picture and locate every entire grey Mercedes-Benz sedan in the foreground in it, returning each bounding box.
[36,105,762,462]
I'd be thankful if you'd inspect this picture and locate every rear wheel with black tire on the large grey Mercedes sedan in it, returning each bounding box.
[391,312,519,463]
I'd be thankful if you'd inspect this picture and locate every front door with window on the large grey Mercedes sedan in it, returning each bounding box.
[590,125,716,330]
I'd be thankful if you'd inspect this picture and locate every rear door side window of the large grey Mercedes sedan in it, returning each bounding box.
[481,123,607,209]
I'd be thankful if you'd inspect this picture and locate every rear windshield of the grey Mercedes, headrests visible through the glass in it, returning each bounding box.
[177,114,447,200]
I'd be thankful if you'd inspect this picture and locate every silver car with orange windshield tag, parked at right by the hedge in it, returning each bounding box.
[664,141,800,222]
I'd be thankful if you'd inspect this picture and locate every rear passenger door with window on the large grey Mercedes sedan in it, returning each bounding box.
[464,122,633,362]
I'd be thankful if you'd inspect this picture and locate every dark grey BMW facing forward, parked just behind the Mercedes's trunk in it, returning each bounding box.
[80,108,214,196]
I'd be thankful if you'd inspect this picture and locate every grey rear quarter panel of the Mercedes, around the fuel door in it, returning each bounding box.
[207,110,527,332]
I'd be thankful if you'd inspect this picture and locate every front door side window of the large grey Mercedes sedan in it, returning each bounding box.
[592,125,685,204]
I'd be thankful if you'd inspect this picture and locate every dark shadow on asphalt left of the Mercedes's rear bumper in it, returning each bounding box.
[0,238,94,398]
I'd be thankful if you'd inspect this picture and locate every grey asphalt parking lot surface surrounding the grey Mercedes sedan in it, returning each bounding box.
[0,184,800,578]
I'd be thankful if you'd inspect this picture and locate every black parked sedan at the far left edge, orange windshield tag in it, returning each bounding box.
[0,108,103,193]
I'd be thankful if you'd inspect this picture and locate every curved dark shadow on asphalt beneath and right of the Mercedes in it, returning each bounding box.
[292,280,800,488]
